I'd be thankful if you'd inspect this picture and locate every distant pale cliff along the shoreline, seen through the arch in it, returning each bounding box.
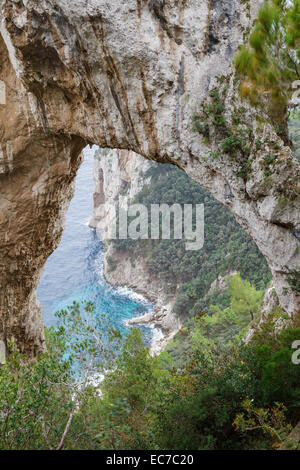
[89,150,182,353]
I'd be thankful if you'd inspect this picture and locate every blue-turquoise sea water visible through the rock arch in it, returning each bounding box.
[37,147,156,342]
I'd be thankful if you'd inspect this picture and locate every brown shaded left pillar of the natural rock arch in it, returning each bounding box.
[0,27,84,354]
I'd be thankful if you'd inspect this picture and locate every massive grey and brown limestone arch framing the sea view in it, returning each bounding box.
[0,0,300,354]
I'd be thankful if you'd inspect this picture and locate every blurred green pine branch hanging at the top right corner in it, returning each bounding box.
[235,0,300,135]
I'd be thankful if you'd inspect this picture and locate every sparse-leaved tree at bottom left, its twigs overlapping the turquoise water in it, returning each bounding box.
[0,302,120,450]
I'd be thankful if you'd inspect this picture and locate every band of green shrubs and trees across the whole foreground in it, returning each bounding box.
[0,300,300,450]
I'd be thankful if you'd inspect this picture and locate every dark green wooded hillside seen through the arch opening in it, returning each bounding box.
[112,164,271,318]
